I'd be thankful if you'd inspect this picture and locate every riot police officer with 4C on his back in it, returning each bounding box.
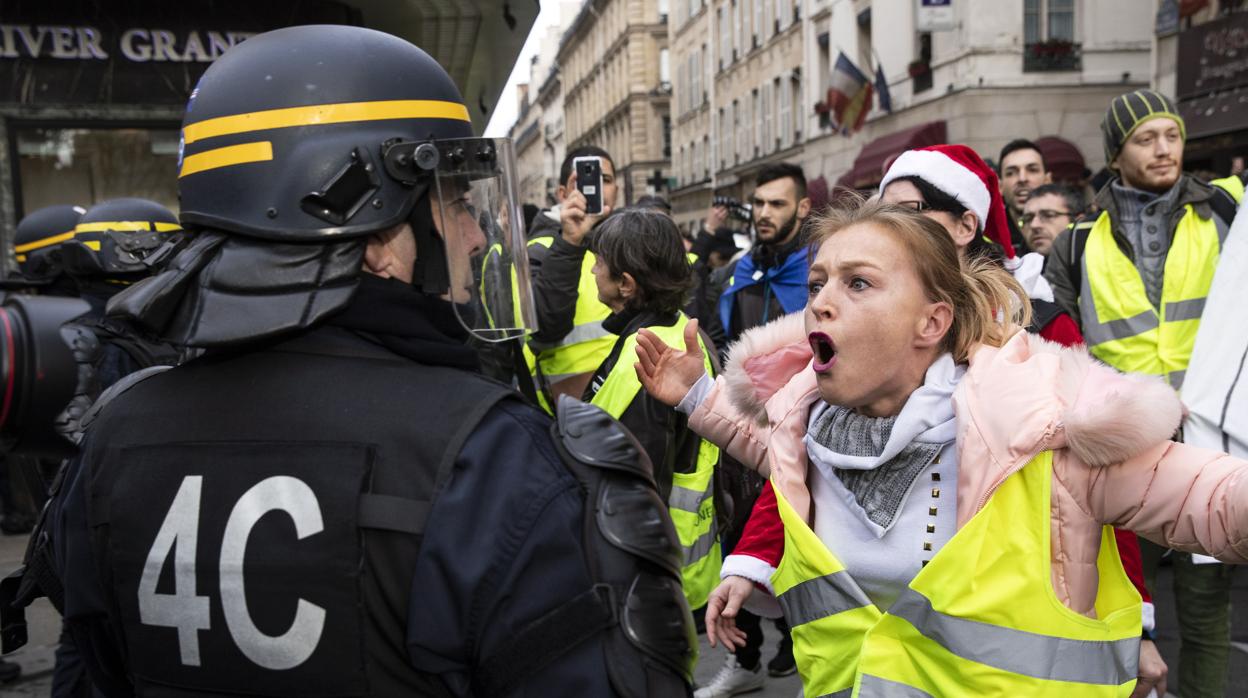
[41,26,695,696]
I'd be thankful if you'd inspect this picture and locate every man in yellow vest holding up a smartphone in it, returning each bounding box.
[527,145,619,408]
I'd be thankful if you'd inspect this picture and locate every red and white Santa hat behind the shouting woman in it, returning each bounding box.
[880,145,1015,260]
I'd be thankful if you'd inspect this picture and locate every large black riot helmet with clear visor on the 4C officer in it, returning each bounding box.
[168,25,535,341]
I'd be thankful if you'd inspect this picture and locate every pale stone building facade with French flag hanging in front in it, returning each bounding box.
[669,0,1156,227]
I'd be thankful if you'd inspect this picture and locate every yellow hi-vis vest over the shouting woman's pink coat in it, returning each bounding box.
[771,451,1141,698]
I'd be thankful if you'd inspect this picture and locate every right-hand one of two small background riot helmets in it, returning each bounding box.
[60,199,182,280]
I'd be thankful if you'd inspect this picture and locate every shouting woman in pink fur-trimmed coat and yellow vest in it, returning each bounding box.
[638,204,1248,697]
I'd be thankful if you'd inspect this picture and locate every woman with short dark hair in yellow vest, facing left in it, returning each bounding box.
[583,209,721,608]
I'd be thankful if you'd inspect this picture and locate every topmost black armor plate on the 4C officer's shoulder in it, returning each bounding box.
[555,395,654,484]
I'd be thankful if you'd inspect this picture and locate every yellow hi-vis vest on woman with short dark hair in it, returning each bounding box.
[590,313,724,609]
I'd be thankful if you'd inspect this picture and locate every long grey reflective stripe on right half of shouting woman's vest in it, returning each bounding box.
[889,589,1139,686]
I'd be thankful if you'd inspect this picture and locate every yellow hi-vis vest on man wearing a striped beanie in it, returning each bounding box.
[1080,177,1243,390]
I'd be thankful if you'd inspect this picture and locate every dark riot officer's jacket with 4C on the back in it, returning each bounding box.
[49,277,628,696]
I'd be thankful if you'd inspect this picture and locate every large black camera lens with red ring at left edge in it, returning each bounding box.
[0,295,90,458]
